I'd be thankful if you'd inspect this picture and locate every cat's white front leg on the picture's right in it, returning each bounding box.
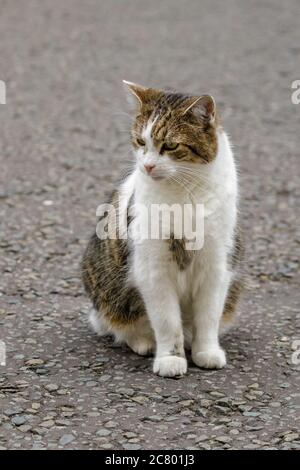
[192,261,230,369]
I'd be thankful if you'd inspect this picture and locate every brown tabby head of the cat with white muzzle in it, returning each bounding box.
[124,82,217,180]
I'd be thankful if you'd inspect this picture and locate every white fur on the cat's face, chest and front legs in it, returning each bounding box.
[115,129,238,376]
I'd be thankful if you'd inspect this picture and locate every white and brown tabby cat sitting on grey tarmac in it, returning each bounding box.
[82,82,244,377]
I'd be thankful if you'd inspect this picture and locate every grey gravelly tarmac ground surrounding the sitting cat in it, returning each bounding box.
[0,0,300,450]
